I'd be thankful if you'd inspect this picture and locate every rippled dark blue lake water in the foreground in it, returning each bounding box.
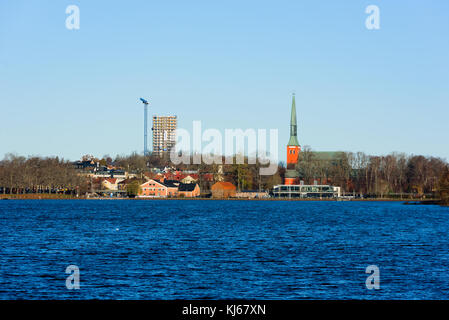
[0,200,449,299]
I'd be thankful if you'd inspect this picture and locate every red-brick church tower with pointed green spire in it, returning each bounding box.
[284,94,301,185]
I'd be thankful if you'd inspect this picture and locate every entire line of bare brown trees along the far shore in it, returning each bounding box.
[0,146,449,198]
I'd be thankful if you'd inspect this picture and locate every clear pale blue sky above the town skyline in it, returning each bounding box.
[0,0,449,160]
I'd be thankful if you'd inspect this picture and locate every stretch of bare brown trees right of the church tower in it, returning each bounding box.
[298,147,448,197]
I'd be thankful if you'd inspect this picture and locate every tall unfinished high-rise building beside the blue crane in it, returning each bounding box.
[152,116,177,157]
